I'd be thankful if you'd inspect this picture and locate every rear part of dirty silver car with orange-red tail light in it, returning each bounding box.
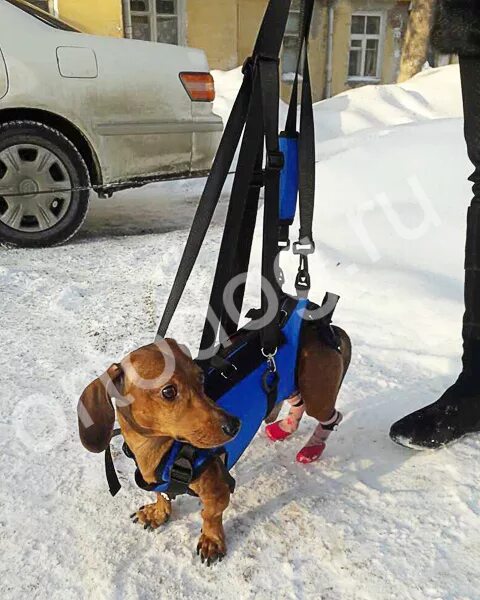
[0,0,223,247]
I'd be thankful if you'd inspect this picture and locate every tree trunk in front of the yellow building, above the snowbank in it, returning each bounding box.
[398,0,435,83]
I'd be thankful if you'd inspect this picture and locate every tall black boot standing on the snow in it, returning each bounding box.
[390,201,480,450]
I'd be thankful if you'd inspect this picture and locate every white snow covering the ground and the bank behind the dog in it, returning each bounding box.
[0,67,480,600]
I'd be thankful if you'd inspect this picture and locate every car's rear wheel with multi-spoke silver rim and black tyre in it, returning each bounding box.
[0,121,90,248]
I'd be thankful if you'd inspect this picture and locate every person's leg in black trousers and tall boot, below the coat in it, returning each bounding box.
[390,57,480,449]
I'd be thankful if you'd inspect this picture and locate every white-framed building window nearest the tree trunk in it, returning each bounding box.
[348,13,383,80]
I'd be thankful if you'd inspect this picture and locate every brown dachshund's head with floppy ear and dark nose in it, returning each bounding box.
[78,340,240,452]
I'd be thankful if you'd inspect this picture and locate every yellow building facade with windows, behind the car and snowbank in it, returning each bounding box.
[33,0,410,100]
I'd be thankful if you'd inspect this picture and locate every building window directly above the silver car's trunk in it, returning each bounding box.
[130,0,182,44]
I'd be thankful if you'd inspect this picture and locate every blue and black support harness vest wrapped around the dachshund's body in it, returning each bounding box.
[124,296,339,498]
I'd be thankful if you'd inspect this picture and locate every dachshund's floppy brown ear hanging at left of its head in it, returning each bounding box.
[77,364,123,453]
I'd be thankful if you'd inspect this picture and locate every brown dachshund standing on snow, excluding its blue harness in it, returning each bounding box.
[78,328,351,564]
